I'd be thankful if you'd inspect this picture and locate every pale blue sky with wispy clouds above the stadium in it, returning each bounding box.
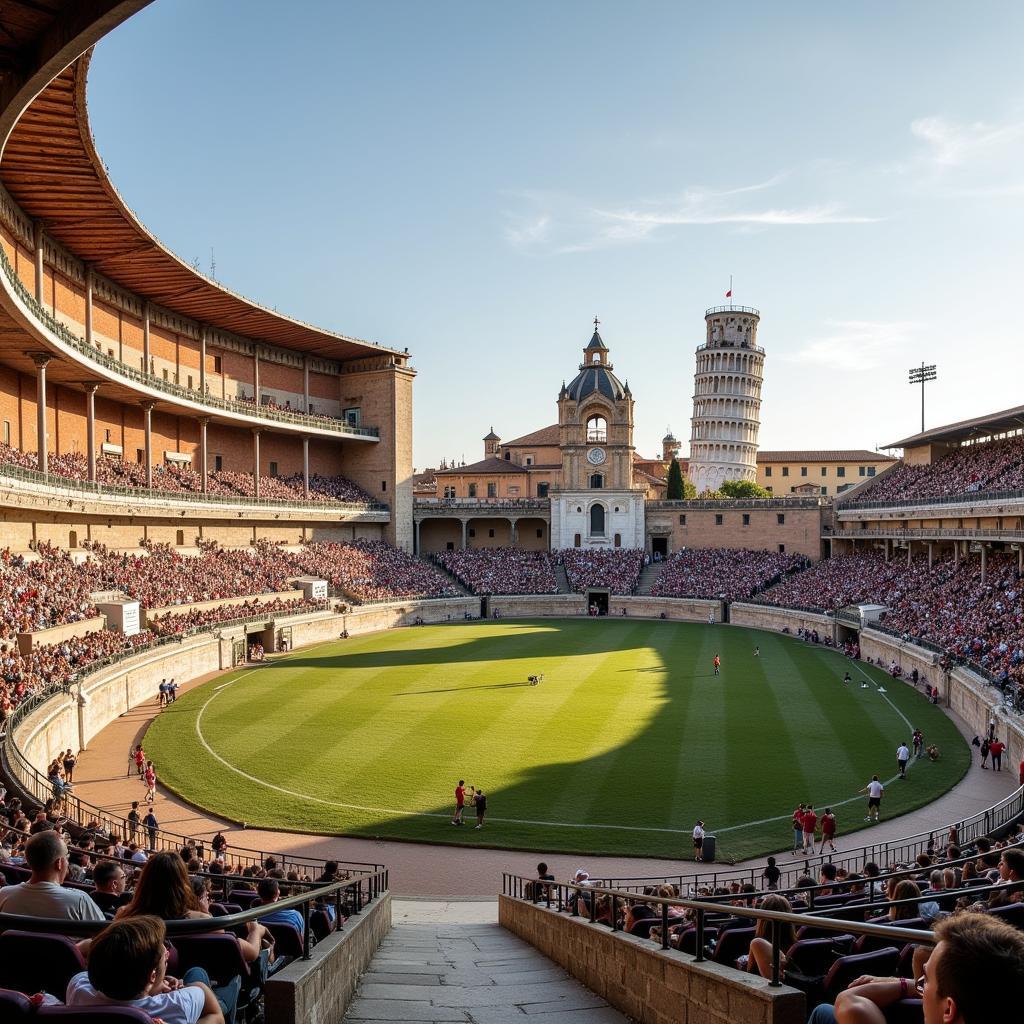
[89,0,1024,468]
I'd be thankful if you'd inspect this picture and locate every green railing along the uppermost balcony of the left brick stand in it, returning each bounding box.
[0,248,380,438]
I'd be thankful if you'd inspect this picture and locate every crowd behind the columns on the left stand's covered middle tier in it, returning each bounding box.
[0,443,374,504]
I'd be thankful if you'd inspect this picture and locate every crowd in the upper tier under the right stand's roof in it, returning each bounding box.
[851,436,1024,505]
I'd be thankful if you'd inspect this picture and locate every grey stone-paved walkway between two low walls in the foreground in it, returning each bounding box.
[345,900,626,1024]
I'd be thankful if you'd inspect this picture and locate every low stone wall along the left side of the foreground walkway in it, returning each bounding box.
[264,892,391,1024]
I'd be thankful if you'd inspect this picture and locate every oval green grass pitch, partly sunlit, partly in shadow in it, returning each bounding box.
[145,618,970,860]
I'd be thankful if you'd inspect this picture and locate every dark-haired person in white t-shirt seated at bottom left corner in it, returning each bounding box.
[65,915,228,1024]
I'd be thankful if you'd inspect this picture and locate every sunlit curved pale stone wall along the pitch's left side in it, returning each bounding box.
[12,598,479,775]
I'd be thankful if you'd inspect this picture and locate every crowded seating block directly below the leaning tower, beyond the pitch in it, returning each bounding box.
[650,548,807,601]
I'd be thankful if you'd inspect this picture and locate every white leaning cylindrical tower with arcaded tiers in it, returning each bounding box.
[687,306,765,495]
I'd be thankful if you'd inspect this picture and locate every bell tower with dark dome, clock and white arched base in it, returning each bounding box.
[551,316,644,548]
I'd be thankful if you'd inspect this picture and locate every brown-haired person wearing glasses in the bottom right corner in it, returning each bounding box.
[808,913,1024,1024]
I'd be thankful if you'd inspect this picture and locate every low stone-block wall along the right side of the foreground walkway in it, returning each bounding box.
[498,895,807,1024]
